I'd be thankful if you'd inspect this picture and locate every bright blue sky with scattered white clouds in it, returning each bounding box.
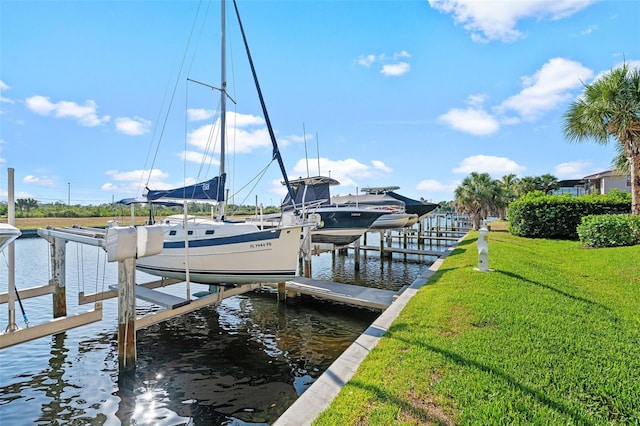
[0,0,640,205]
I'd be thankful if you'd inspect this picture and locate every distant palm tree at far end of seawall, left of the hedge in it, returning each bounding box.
[454,172,499,229]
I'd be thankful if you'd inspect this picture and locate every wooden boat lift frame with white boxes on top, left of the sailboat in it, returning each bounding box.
[0,168,252,372]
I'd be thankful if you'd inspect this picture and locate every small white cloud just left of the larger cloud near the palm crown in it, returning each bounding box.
[438,95,500,136]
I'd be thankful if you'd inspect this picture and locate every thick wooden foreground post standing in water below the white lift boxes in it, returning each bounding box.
[118,257,136,374]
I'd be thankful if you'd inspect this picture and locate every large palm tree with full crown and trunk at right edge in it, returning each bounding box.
[564,63,640,215]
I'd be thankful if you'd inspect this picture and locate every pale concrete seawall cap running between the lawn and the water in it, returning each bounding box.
[273,234,468,426]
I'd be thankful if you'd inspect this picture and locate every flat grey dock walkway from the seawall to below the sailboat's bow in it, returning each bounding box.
[274,277,398,311]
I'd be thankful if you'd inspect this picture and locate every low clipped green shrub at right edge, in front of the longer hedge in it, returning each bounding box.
[577,214,640,247]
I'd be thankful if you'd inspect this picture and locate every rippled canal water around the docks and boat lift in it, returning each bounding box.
[0,238,444,425]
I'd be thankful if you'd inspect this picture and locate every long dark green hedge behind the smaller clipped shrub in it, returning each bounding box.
[507,191,631,240]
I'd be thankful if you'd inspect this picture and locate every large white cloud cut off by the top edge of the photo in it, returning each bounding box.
[429,0,595,42]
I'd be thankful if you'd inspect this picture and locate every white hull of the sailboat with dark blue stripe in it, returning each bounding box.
[136,221,302,284]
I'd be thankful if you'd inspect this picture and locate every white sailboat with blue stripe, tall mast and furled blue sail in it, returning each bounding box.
[136,0,302,284]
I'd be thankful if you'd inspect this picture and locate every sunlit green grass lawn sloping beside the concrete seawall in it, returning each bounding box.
[314,223,640,426]
